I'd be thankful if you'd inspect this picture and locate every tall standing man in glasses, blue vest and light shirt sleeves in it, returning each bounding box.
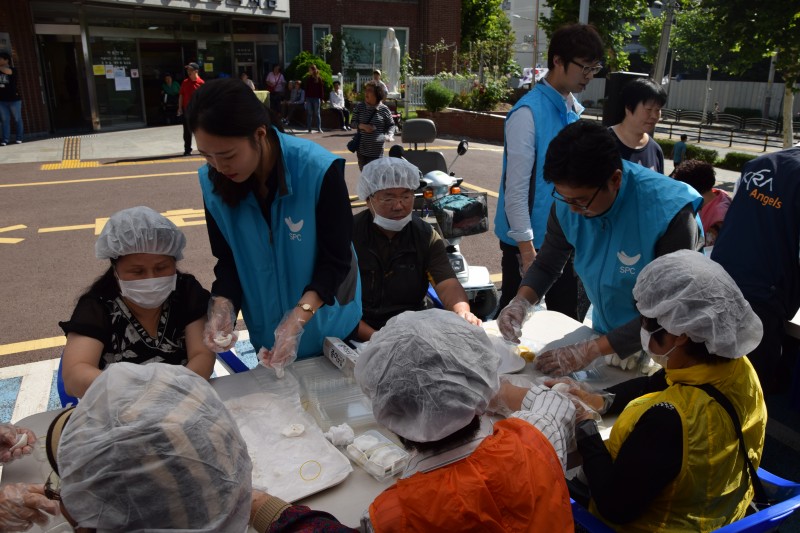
[494,24,603,319]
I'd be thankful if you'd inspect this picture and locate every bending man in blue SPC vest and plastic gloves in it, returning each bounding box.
[497,121,703,375]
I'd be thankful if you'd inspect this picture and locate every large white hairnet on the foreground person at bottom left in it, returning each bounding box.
[58,363,252,532]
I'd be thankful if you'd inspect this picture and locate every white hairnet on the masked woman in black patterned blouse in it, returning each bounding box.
[94,205,186,259]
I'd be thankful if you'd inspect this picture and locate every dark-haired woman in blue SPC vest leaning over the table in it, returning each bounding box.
[187,79,361,375]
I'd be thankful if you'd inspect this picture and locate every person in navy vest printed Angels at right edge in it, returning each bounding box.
[711,145,800,392]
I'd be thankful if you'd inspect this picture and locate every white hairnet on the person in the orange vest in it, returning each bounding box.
[355,309,500,442]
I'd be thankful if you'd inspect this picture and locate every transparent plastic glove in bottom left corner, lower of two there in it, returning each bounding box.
[0,483,59,531]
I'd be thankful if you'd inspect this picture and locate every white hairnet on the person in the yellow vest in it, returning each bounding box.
[633,250,763,359]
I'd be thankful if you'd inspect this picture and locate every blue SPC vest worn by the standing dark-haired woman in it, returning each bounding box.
[198,128,361,359]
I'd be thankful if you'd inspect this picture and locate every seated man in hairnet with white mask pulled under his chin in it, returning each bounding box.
[353,157,481,341]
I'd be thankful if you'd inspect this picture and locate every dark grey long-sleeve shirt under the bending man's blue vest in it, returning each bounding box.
[522,204,703,358]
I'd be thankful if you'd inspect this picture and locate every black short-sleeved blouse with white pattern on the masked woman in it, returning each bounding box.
[58,273,210,369]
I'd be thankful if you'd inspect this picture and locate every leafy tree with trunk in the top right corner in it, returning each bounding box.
[703,0,800,148]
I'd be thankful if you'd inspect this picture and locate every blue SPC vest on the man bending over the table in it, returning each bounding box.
[556,160,703,333]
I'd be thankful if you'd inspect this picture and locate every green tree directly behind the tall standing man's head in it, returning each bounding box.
[539,0,648,70]
